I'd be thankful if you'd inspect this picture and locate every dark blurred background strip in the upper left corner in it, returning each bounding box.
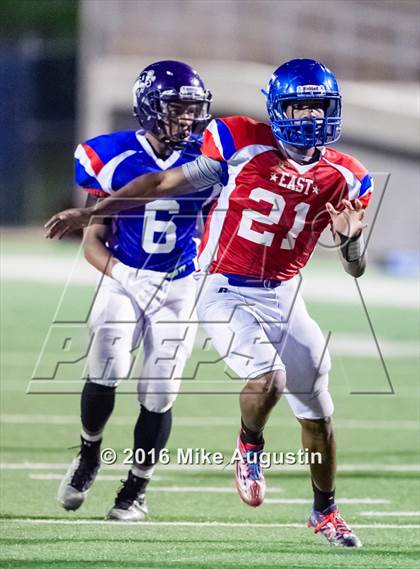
[0,0,78,224]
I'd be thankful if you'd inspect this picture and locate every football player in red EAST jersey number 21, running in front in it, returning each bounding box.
[46,59,373,547]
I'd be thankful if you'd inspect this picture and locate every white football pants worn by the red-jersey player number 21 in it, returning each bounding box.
[197,274,334,419]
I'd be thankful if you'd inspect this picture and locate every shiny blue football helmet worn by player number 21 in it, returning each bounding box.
[263,59,341,148]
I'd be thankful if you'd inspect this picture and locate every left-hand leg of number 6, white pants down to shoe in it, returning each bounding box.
[57,277,138,510]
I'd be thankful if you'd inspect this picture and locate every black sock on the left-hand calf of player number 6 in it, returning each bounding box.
[80,379,116,442]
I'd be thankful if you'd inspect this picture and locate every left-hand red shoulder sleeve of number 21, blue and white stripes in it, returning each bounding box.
[201,116,275,162]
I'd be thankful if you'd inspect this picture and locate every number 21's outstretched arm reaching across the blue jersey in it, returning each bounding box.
[45,156,222,239]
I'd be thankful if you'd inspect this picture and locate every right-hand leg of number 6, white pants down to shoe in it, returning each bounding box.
[108,277,197,521]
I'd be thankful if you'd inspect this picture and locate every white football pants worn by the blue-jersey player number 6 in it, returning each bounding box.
[88,271,197,413]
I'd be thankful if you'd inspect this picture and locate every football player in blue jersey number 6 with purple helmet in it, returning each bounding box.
[58,61,217,521]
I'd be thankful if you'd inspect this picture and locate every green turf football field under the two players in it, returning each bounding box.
[0,250,420,569]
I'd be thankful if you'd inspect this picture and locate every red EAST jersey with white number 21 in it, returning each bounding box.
[199,116,373,280]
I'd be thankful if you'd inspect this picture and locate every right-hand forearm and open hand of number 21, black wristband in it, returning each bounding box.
[326,200,366,278]
